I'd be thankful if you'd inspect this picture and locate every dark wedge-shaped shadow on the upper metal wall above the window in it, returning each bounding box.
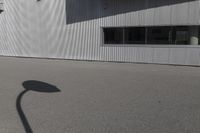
[66,0,196,24]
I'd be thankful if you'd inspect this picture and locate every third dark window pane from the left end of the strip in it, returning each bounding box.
[147,26,172,44]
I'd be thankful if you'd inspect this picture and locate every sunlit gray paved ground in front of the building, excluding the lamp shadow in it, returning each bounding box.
[0,57,200,133]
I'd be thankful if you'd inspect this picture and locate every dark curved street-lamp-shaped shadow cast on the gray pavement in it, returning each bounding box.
[16,80,60,133]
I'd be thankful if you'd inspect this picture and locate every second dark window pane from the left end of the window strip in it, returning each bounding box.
[125,27,145,44]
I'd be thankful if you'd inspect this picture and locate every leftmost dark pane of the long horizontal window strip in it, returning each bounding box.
[103,28,123,44]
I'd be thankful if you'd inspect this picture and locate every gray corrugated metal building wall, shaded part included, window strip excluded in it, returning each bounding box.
[0,0,200,65]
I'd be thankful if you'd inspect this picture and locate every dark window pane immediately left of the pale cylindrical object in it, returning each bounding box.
[172,26,189,44]
